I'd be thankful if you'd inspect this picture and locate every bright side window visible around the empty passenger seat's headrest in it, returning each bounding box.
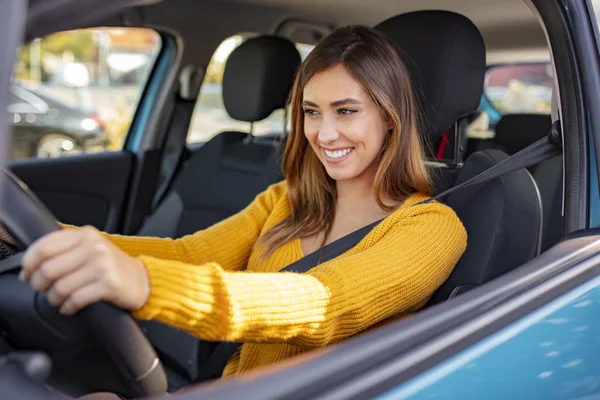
[187,35,314,143]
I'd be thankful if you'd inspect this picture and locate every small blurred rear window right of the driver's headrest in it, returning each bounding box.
[484,62,554,115]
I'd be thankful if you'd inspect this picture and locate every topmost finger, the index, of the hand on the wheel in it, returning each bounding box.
[19,228,87,281]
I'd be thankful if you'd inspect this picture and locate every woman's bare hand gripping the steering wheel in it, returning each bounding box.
[19,227,150,315]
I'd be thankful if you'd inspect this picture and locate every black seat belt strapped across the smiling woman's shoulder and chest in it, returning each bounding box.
[193,125,562,382]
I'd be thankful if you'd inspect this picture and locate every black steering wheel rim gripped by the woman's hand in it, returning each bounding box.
[0,170,167,397]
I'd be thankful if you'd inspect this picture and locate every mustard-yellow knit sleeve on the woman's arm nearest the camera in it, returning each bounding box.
[135,203,466,347]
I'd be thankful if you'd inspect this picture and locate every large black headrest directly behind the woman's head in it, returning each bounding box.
[376,11,486,140]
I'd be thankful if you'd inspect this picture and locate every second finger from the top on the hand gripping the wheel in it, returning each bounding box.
[29,246,88,292]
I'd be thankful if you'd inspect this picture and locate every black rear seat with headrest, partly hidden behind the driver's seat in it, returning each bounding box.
[491,114,563,252]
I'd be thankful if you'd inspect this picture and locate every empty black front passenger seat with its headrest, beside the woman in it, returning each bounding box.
[138,35,300,238]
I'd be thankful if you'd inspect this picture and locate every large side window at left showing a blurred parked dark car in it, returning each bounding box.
[8,28,161,159]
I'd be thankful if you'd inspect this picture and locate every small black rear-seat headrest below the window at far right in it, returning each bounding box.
[494,114,552,154]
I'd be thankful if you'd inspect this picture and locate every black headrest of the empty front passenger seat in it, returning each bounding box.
[223,35,300,122]
